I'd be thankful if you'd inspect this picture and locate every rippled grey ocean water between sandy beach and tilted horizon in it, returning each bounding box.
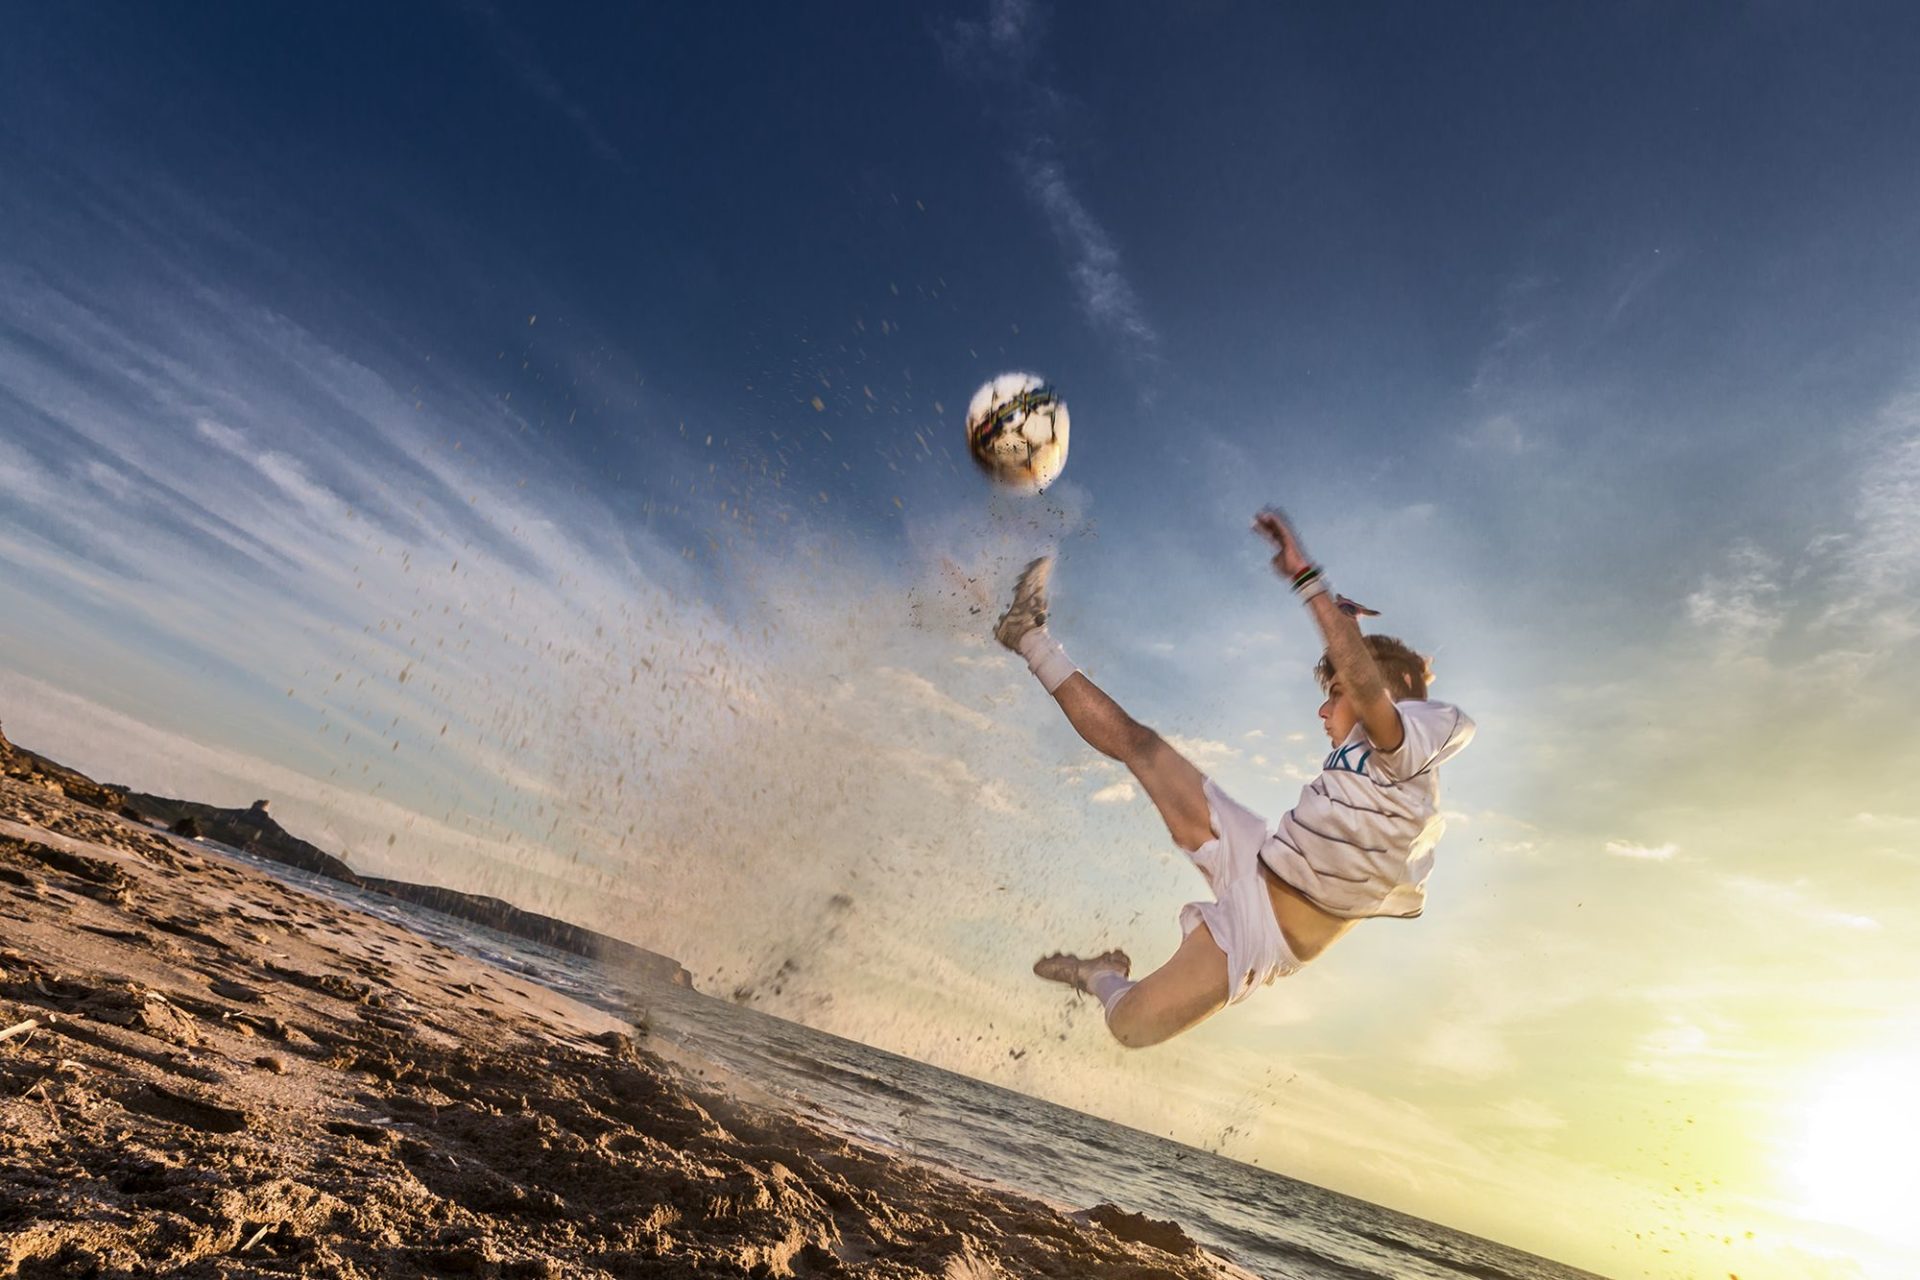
[209,842,1594,1280]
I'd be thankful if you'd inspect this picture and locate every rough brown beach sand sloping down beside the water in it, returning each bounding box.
[0,779,1246,1280]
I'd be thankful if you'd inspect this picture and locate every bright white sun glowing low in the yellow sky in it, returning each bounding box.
[1793,1057,1920,1236]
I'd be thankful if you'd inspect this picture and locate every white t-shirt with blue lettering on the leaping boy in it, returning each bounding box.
[1260,700,1473,919]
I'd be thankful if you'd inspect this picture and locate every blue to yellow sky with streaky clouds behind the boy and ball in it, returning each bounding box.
[0,0,1920,1280]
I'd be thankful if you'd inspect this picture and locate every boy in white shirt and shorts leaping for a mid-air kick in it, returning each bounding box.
[995,509,1473,1048]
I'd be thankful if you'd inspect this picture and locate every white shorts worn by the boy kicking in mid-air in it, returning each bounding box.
[1181,777,1300,1004]
